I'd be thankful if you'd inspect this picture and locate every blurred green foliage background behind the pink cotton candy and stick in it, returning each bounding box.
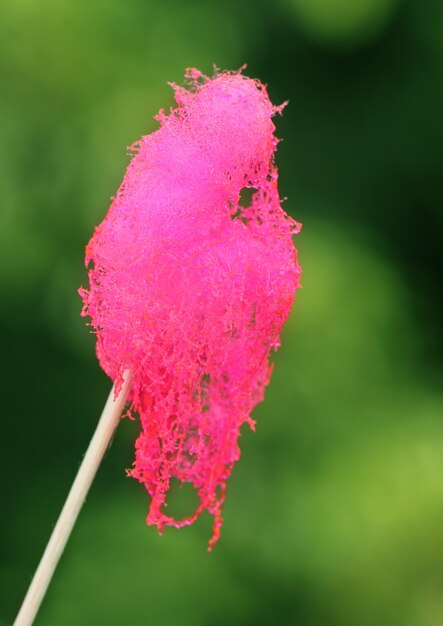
[0,0,443,626]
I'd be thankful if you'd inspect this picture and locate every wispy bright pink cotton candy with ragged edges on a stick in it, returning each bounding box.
[80,69,300,548]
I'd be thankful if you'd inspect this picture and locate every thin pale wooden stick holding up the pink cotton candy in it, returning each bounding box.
[14,371,131,626]
